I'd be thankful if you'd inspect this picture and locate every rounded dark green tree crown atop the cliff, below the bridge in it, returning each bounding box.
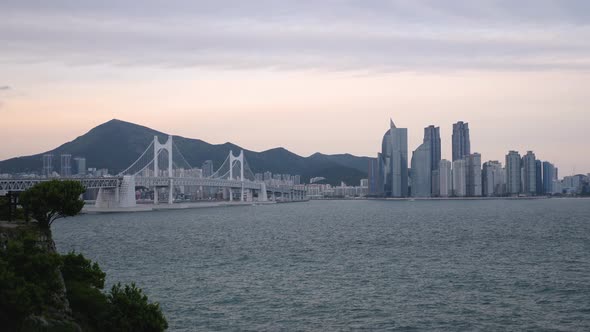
[20,180,86,228]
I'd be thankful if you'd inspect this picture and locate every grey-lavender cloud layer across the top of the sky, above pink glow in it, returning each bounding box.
[0,0,590,71]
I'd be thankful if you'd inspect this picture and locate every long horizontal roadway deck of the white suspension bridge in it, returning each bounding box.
[0,176,300,196]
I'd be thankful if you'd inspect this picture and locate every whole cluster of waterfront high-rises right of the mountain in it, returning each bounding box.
[368,121,589,197]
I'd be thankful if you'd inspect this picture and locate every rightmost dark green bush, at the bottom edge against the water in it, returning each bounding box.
[105,283,168,332]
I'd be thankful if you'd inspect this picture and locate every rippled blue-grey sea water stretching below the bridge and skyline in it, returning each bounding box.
[53,199,590,331]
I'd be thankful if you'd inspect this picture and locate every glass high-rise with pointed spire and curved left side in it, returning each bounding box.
[379,120,408,197]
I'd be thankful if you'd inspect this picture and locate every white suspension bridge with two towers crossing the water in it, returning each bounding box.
[0,136,306,209]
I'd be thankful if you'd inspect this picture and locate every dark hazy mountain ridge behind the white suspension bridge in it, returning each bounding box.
[0,119,369,185]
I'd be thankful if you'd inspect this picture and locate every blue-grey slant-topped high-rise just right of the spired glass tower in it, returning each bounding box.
[411,139,432,197]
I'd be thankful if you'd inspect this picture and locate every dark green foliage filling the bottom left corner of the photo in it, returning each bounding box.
[0,233,62,330]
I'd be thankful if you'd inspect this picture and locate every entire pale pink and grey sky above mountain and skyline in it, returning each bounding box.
[0,0,590,175]
